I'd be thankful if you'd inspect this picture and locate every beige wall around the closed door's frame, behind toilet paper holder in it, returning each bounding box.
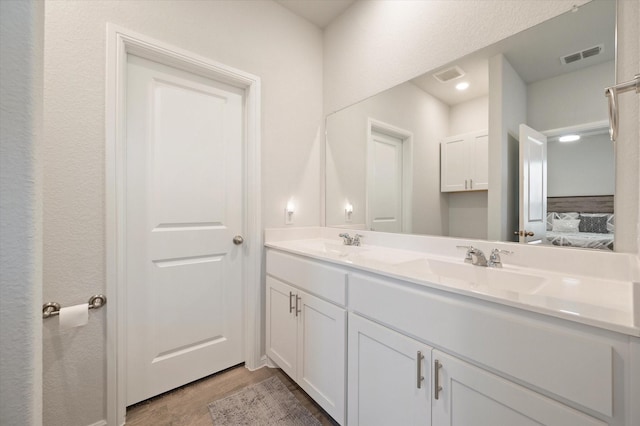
[44,0,323,426]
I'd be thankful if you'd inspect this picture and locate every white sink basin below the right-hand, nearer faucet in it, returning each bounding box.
[399,258,546,294]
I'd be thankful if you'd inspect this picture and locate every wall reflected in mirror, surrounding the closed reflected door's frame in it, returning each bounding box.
[326,82,449,235]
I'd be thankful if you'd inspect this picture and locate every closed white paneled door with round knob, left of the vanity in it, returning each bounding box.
[124,55,244,405]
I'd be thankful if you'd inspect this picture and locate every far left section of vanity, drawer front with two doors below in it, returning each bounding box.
[266,251,347,424]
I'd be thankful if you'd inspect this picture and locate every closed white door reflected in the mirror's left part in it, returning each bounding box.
[367,131,403,232]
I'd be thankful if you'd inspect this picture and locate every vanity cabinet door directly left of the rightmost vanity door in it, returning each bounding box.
[348,314,431,426]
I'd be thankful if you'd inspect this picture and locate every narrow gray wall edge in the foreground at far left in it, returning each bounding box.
[0,1,44,426]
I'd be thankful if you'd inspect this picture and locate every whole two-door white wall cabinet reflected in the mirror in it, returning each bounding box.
[440,130,489,192]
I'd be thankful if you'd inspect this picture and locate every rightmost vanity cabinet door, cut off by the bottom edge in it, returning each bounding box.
[432,350,606,426]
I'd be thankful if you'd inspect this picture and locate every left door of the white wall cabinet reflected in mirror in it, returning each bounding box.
[440,135,469,192]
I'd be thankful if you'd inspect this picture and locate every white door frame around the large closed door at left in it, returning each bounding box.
[105,23,264,425]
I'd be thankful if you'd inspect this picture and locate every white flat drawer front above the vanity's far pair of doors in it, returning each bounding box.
[267,250,347,306]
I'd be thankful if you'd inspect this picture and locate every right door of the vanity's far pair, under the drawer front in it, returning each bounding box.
[296,292,347,424]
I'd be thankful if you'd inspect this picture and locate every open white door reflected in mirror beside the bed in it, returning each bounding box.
[517,124,547,244]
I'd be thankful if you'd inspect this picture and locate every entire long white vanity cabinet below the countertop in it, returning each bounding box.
[266,245,640,426]
